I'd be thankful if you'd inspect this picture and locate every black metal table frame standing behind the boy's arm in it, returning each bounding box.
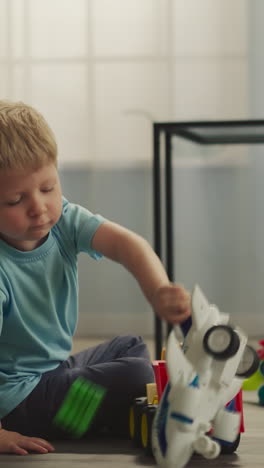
[153,120,264,359]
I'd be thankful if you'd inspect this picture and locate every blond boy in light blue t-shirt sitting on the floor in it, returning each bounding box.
[0,101,190,455]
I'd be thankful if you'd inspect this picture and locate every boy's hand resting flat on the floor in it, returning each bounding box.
[0,429,55,455]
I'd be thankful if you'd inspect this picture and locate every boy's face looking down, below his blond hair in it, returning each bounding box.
[0,164,62,251]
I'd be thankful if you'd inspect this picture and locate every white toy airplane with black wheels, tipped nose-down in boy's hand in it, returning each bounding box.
[152,286,258,468]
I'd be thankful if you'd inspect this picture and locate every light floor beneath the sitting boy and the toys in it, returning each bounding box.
[0,340,264,468]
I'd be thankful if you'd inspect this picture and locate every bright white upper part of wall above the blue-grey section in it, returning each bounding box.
[0,0,249,168]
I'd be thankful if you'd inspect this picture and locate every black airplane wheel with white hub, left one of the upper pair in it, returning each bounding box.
[203,325,240,361]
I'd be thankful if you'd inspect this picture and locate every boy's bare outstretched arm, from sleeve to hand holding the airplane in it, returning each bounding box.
[92,221,191,324]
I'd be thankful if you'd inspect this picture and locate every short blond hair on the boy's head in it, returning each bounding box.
[0,100,57,170]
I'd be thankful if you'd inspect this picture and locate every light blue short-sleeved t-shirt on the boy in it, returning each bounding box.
[0,198,105,420]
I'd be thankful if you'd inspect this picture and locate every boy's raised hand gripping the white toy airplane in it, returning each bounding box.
[151,283,191,325]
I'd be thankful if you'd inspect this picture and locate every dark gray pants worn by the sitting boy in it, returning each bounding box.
[2,335,154,440]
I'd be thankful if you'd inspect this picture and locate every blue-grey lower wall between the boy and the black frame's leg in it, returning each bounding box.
[60,168,153,336]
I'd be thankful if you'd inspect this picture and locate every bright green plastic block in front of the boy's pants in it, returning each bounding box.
[53,377,106,438]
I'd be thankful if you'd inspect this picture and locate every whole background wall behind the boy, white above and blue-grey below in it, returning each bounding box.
[0,0,263,335]
